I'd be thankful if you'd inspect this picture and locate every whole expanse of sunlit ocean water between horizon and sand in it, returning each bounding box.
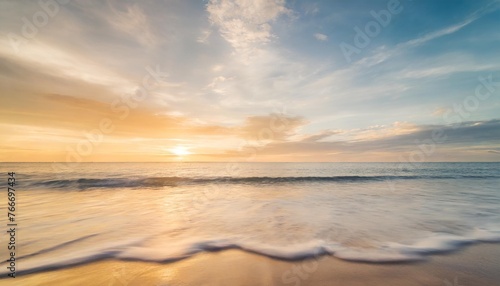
[0,163,500,276]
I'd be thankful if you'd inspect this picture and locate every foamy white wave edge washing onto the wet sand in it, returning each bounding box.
[0,230,500,277]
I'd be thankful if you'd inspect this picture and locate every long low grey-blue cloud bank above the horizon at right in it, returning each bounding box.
[238,120,500,161]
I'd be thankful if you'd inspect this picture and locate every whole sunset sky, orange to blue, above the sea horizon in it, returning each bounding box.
[0,0,500,162]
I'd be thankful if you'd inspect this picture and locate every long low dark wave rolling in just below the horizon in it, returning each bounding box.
[31,175,499,190]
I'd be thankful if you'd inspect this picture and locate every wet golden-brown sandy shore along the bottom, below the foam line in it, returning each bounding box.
[4,244,500,286]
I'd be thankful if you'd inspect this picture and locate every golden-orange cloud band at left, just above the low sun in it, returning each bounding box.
[0,94,234,138]
